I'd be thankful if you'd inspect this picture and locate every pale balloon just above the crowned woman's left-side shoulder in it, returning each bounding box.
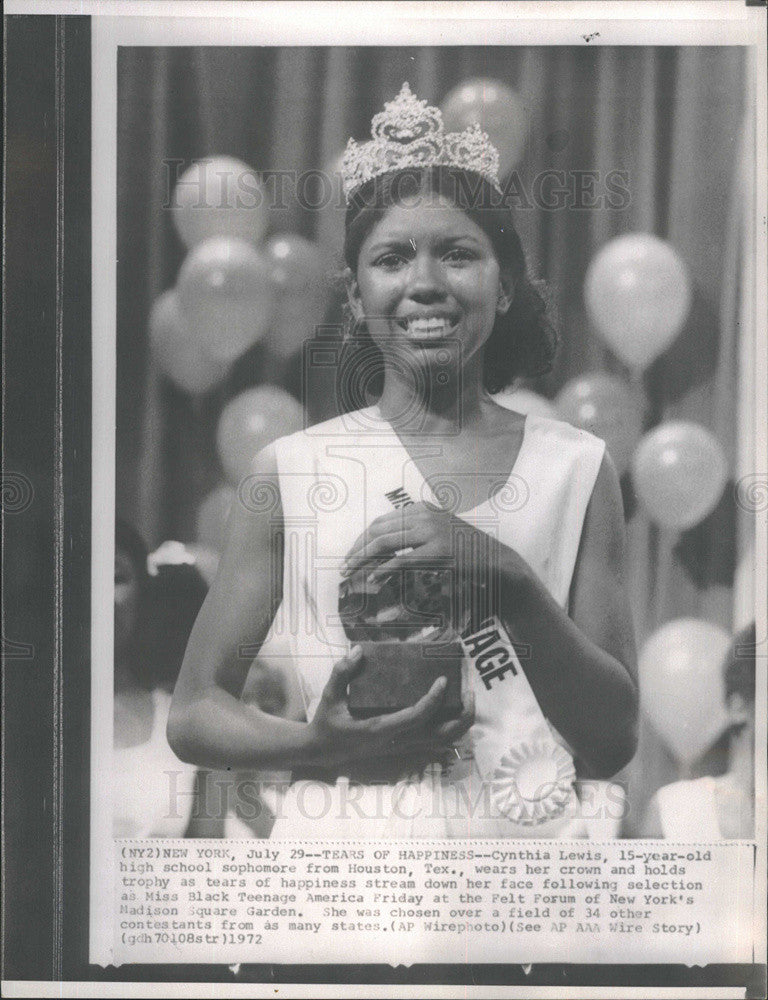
[216,385,304,485]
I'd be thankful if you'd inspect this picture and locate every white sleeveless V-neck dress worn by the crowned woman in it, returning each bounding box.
[272,406,616,839]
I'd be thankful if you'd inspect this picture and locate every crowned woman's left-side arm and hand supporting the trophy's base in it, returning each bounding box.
[168,448,472,770]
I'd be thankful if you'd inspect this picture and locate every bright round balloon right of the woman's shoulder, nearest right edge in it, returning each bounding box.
[632,420,728,531]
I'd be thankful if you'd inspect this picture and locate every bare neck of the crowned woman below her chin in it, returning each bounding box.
[379,352,485,436]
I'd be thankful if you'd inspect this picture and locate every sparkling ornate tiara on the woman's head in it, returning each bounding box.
[341,83,501,203]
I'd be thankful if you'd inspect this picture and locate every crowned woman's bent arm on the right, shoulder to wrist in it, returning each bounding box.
[500,452,638,777]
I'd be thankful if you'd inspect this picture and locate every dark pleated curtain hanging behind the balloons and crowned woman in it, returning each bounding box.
[116,45,745,831]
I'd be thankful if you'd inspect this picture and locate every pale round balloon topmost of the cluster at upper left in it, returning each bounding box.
[171,156,267,247]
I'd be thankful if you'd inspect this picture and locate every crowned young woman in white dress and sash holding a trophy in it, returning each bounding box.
[169,85,638,837]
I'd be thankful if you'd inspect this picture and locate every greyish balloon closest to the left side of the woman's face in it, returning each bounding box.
[266,235,328,358]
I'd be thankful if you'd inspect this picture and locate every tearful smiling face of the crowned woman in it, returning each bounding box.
[347,195,512,364]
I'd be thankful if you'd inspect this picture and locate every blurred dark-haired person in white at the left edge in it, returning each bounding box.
[113,520,207,837]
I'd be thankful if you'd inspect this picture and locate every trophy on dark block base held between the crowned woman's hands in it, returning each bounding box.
[339,567,463,719]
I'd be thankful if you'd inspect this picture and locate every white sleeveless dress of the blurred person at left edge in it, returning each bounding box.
[112,688,197,837]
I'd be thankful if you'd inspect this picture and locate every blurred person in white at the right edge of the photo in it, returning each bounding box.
[644,623,755,842]
